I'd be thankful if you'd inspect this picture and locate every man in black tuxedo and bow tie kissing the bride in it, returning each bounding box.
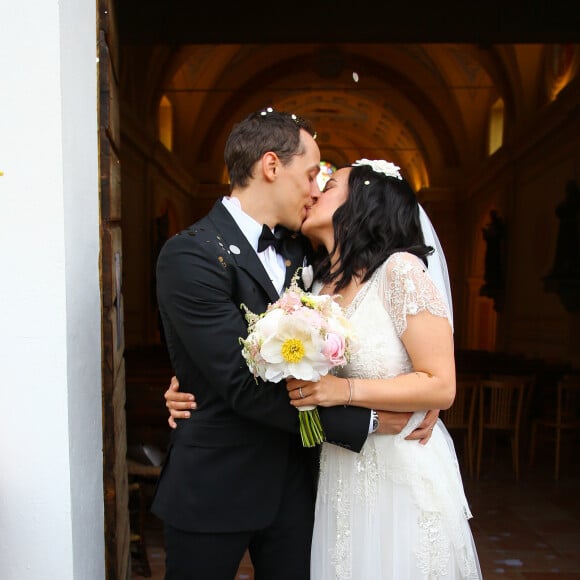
[152,109,436,580]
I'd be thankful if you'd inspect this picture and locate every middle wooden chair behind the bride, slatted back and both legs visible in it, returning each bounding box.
[477,377,526,481]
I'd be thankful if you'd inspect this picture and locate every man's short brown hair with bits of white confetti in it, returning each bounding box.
[224,108,316,191]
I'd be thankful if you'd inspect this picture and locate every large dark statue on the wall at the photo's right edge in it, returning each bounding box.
[544,180,580,311]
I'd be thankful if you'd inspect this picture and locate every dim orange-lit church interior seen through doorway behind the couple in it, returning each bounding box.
[101,0,580,579]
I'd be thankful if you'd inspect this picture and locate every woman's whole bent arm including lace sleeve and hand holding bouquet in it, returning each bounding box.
[288,253,455,411]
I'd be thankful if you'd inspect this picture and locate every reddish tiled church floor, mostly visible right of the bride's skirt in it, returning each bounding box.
[133,444,580,580]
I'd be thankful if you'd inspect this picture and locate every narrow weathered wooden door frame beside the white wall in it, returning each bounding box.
[96,0,131,580]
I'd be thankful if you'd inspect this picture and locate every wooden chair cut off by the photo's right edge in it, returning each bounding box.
[530,375,580,481]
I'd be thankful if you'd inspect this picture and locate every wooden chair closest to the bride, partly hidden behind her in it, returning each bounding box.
[441,379,479,477]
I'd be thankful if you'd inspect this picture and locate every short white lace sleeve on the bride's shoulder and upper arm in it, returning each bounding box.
[379,253,449,336]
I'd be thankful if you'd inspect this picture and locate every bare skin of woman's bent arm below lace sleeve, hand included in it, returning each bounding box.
[287,310,455,411]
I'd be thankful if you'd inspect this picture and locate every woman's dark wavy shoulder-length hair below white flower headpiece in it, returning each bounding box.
[316,165,433,291]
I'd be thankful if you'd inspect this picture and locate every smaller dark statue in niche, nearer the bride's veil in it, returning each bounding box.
[479,209,505,311]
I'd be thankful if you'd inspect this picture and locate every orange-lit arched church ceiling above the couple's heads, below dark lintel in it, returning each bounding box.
[131,44,542,189]
